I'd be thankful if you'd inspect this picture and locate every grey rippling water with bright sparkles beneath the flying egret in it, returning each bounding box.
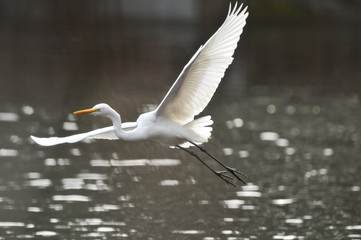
[0,88,361,239]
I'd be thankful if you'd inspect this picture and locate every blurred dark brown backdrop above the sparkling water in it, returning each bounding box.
[0,0,361,106]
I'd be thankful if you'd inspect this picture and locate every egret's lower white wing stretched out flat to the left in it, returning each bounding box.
[30,122,137,146]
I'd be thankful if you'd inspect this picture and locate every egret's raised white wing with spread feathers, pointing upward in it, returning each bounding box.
[156,4,248,124]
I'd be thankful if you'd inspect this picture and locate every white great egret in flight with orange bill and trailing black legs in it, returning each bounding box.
[31,3,248,186]
